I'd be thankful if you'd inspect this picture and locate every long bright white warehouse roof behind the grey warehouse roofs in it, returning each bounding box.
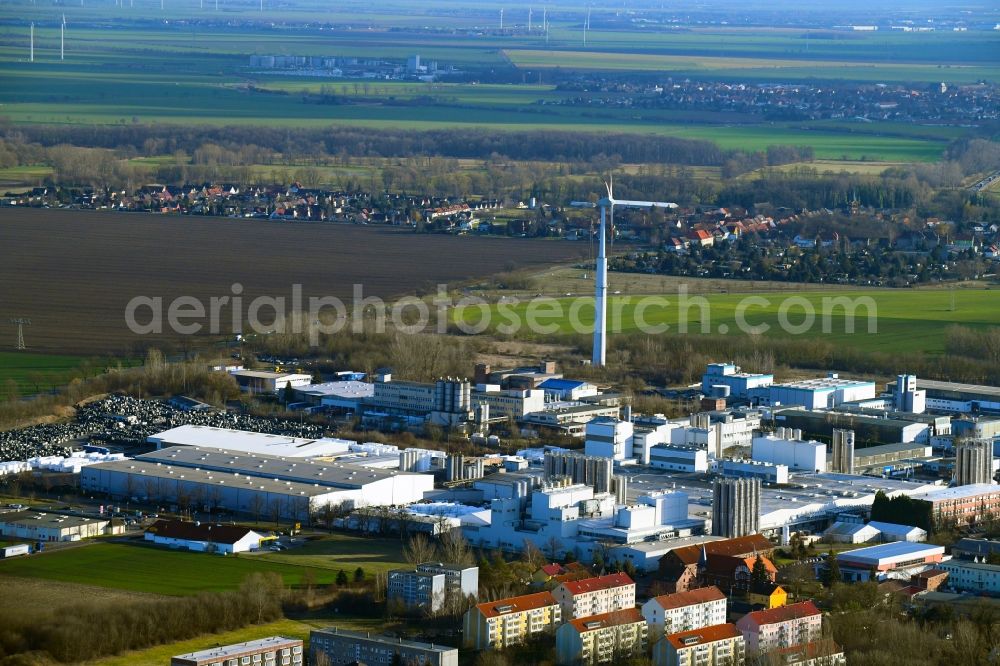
[146,425,351,458]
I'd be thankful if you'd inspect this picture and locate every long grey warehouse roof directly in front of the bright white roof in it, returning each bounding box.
[135,446,410,488]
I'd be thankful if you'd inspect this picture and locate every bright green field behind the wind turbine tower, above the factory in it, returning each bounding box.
[454,288,1000,354]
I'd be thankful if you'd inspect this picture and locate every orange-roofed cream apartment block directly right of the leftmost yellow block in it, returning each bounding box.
[556,608,648,666]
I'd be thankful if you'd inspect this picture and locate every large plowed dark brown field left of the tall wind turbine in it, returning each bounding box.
[0,208,582,354]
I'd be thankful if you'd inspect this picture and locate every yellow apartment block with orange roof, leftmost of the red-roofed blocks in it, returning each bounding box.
[463,592,562,650]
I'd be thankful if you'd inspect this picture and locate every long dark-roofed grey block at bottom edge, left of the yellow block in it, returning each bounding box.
[310,627,458,666]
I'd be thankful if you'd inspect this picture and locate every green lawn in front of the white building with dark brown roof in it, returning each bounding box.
[0,543,340,596]
